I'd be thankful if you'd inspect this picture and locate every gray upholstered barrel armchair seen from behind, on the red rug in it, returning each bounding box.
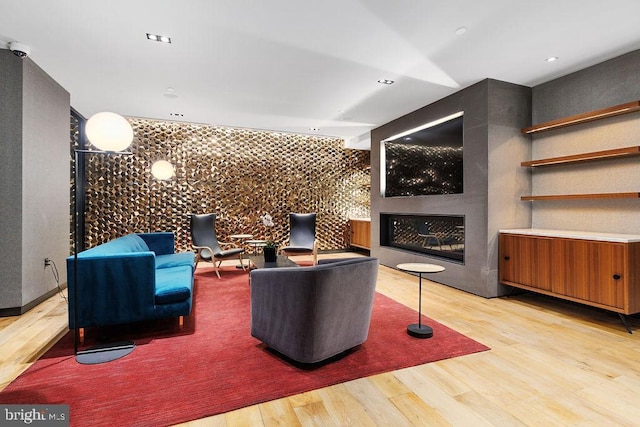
[251,257,378,363]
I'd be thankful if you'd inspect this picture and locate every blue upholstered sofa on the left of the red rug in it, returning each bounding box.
[67,233,195,329]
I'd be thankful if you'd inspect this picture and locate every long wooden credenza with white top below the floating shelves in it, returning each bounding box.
[499,229,640,318]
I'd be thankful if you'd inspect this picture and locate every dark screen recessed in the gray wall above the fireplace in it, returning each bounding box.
[381,115,463,197]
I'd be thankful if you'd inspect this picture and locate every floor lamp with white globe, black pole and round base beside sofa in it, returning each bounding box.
[73,112,135,365]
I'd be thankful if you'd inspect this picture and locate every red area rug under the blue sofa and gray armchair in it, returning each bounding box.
[0,267,488,426]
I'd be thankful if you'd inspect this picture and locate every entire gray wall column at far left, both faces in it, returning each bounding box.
[0,50,70,313]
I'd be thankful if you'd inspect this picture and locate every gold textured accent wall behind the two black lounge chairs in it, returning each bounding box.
[85,119,370,251]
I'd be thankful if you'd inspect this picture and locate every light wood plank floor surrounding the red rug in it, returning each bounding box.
[0,254,640,427]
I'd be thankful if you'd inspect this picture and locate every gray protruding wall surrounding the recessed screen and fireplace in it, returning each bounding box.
[371,80,531,297]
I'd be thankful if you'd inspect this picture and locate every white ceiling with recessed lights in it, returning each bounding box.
[0,0,640,149]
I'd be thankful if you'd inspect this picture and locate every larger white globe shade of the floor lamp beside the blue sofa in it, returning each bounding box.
[85,112,133,151]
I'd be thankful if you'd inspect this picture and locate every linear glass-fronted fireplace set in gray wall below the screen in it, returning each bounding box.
[380,213,464,262]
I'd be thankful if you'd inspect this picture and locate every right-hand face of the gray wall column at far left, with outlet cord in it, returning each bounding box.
[22,59,70,305]
